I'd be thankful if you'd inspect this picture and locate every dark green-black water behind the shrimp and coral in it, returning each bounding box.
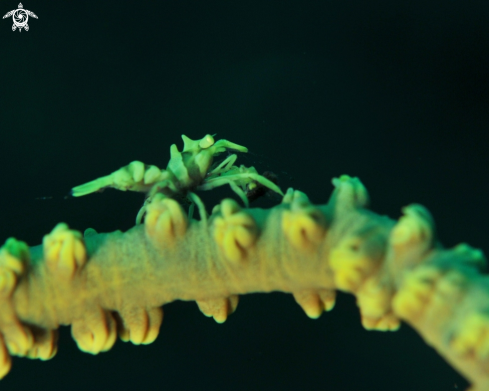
[0,0,489,391]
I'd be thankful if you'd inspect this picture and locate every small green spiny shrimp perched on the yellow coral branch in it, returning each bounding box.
[71,134,284,224]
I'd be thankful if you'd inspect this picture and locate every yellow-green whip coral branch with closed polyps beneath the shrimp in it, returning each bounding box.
[0,139,489,391]
